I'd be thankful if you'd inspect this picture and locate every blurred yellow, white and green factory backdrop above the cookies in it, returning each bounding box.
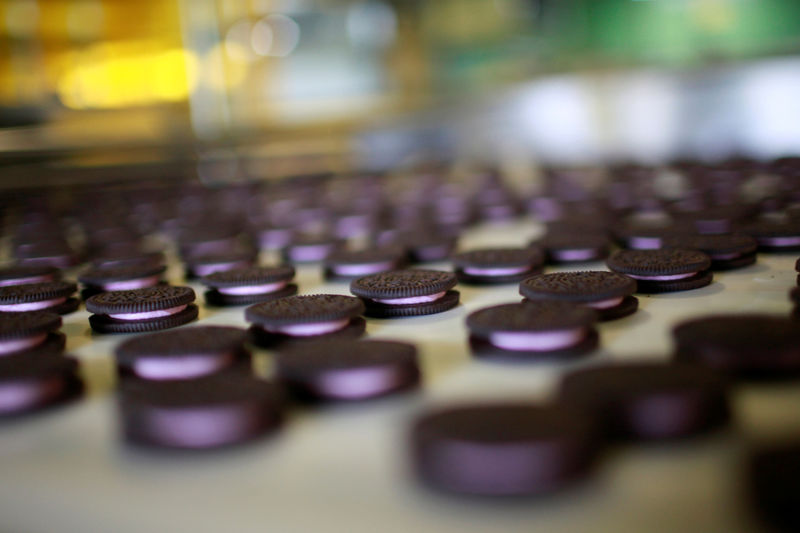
[0,0,800,187]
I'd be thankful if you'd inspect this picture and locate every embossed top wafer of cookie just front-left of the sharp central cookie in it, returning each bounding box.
[244,294,364,327]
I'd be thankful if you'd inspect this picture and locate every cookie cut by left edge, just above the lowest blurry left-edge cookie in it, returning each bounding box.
[0,311,66,357]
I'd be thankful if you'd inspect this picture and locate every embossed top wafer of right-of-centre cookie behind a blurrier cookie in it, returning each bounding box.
[519,271,636,302]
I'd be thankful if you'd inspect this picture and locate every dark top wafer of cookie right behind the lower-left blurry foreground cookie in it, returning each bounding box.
[115,326,247,363]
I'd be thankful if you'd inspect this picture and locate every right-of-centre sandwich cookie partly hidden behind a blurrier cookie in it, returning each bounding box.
[519,271,639,321]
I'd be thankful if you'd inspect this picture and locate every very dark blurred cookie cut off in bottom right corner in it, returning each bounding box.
[745,436,800,532]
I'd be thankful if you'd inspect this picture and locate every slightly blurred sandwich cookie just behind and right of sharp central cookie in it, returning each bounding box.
[453,247,544,285]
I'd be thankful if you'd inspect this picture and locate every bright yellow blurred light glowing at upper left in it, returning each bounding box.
[58,42,198,109]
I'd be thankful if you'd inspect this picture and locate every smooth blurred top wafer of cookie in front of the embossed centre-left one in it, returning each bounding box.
[276,340,417,377]
